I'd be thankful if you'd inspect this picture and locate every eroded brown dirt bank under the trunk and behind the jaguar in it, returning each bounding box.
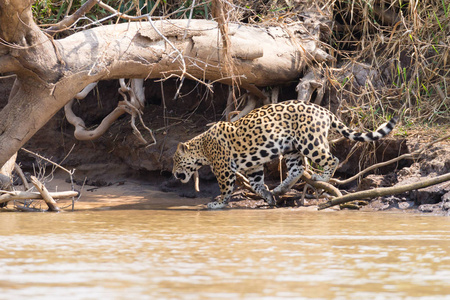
[0,79,450,214]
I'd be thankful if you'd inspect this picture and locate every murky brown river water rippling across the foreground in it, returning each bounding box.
[0,209,450,299]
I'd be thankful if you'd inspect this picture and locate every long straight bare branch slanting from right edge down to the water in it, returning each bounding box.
[318,173,450,210]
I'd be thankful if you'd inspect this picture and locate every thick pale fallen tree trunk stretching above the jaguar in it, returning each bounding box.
[0,0,332,165]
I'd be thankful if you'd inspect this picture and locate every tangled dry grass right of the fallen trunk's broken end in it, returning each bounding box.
[329,0,450,125]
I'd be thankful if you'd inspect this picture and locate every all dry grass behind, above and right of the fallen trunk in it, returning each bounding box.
[34,0,450,128]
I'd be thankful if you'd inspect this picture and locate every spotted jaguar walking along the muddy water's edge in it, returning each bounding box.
[172,100,397,209]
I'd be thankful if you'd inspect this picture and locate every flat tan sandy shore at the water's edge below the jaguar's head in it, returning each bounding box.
[25,174,326,211]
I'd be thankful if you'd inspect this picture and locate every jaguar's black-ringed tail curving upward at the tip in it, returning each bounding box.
[331,115,398,142]
